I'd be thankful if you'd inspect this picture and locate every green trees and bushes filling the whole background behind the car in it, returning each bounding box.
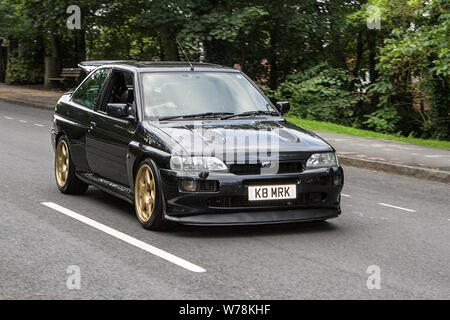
[0,0,450,139]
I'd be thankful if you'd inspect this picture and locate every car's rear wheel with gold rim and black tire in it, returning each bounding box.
[54,136,89,194]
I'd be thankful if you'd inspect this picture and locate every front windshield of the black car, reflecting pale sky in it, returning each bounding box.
[142,72,276,119]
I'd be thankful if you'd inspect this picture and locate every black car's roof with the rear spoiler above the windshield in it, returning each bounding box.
[78,60,239,72]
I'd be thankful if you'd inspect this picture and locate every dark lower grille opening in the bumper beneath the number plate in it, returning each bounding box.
[208,192,326,208]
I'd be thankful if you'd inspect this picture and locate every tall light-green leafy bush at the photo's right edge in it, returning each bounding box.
[365,0,450,140]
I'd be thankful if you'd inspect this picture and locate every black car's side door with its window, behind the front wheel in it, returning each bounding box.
[86,69,138,186]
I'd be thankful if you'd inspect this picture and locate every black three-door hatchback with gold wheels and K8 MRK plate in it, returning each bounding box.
[52,61,343,229]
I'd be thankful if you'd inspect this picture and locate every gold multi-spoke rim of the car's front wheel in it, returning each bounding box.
[134,164,156,222]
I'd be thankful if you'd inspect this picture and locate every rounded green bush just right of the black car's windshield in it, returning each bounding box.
[269,63,360,125]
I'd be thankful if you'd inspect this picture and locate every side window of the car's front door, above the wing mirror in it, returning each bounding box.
[100,70,136,117]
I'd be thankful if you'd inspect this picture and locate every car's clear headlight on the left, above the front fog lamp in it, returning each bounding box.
[170,156,228,171]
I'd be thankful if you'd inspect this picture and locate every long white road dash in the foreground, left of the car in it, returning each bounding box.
[41,202,206,272]
